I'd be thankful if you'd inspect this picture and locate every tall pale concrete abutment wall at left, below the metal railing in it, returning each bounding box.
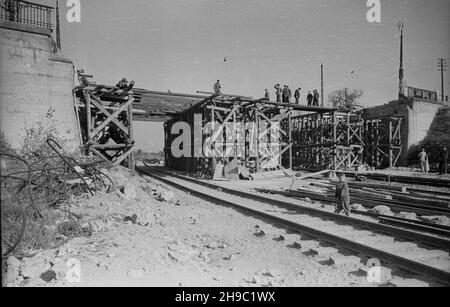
[0,22,79,148]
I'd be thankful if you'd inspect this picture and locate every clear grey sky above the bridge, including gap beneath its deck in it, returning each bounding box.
[43,0,450,151]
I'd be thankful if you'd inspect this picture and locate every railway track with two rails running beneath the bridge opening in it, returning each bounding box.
[138,167,450,285]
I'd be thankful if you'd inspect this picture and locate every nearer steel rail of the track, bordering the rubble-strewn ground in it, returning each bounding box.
[136,167,450,285]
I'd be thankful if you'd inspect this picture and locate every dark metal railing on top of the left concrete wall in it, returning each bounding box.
[0,0,54,30]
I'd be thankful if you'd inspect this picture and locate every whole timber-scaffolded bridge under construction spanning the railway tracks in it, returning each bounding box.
[76,73,442,179]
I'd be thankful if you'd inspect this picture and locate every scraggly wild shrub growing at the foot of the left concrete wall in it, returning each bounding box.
[0,109,81,253]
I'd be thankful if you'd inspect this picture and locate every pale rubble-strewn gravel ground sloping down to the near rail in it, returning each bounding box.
[4,169,375,287]
